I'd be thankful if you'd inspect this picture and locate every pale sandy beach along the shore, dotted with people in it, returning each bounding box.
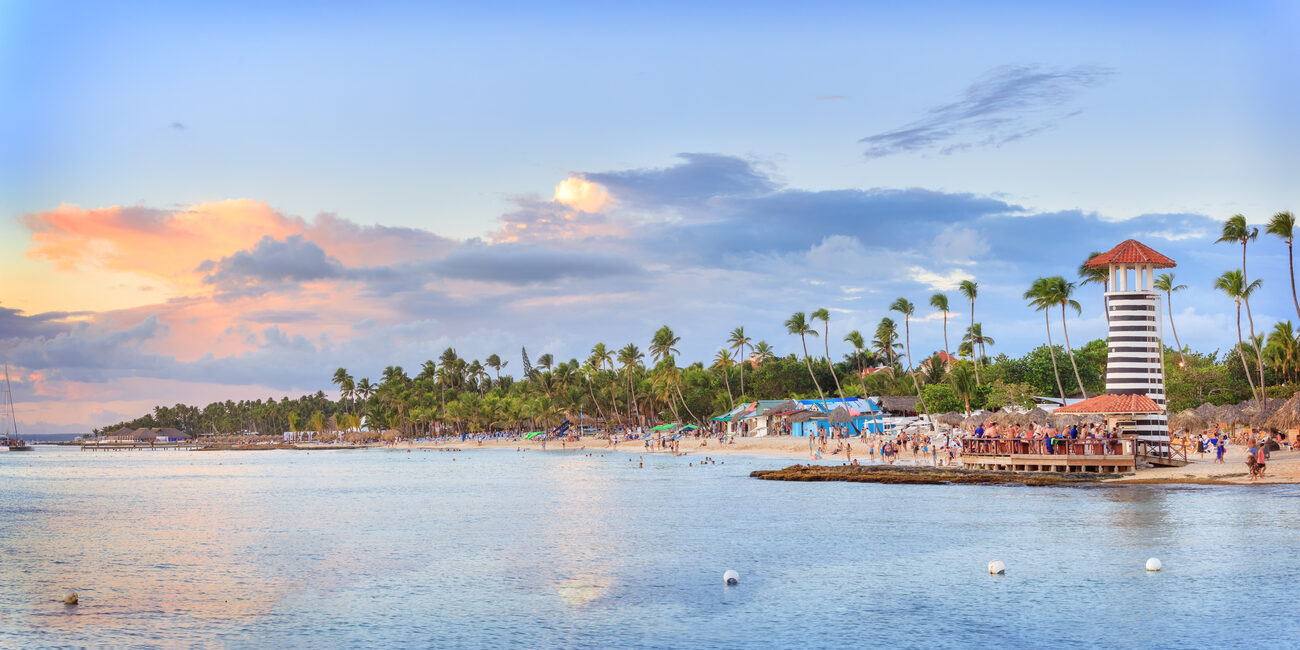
[397,437,1300,485]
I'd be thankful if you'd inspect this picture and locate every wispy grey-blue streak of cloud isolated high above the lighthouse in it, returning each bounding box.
[858,65,1114,159]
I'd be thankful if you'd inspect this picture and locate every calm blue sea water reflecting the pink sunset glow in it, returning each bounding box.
[0,447,1300,647]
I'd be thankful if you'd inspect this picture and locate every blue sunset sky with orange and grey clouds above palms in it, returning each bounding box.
[0,0,1300,433]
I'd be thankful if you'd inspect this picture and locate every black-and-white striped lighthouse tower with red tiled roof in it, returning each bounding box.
[1087,239,1177,445]
